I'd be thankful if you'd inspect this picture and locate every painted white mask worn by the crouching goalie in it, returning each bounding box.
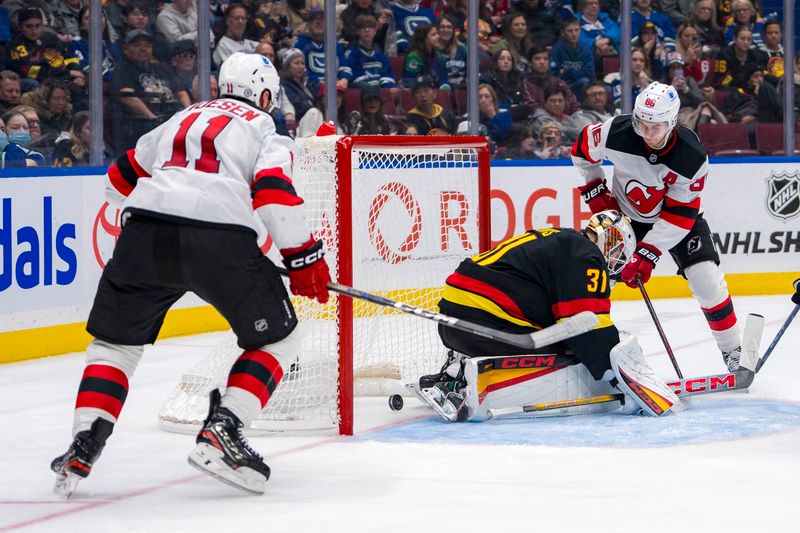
[585,209,636,276]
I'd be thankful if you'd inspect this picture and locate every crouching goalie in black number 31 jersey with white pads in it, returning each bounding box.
[409,210,682,421]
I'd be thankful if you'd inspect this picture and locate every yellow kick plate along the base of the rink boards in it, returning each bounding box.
[0,272,798,363]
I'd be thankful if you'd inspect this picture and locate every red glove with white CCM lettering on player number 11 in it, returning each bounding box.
[281,237,331,304]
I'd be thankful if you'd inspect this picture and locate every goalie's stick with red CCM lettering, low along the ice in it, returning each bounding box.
[522,368,755,413]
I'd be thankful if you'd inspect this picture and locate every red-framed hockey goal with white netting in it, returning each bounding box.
[159,135,490,435]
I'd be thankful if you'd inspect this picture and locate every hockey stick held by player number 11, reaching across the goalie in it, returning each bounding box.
[277,267,598,350]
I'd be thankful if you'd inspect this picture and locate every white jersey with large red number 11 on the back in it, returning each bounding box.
[108,98,311,249]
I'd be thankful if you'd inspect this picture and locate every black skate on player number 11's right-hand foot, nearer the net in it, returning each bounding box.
[189,389,269,494]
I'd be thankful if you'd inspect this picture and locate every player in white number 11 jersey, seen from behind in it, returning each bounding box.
[51,53,330,497]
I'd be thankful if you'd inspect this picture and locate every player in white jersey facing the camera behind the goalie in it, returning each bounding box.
[572,82,741,372]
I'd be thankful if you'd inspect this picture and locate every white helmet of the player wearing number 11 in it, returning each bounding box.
[219,52,281,111]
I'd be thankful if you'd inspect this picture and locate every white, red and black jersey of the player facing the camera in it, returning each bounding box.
[572,115,708,252]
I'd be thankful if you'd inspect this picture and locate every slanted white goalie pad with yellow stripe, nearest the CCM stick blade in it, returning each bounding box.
[610,336,683,416]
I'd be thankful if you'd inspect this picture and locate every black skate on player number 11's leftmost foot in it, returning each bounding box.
[50,418,114,498]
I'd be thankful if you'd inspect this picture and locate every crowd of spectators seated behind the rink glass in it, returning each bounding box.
[0,0,800,168]
